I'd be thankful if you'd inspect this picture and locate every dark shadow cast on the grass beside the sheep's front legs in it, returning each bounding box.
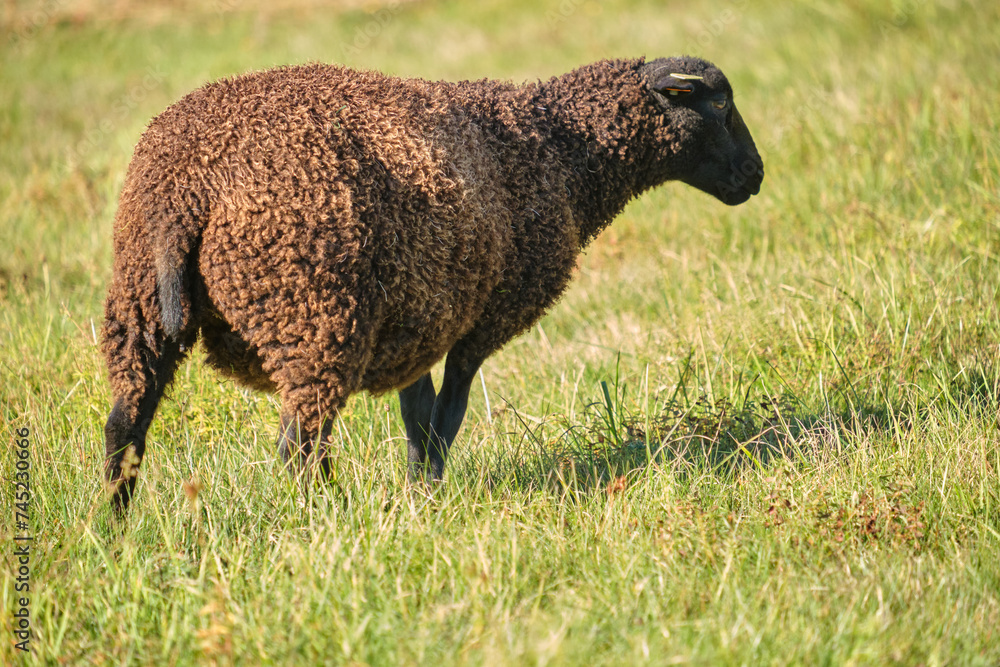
[470,375,976,496]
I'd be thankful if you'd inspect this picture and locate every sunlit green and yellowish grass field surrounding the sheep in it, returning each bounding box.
[0,0,1000,665]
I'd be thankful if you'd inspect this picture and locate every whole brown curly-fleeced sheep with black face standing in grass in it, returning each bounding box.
[102,56,764,514]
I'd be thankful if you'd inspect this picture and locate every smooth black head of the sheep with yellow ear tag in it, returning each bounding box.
[643,57,764,206]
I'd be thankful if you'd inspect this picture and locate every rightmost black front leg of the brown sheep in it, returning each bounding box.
[427,346,483,481]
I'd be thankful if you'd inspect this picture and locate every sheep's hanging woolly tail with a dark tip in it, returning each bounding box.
[153,192,204,341]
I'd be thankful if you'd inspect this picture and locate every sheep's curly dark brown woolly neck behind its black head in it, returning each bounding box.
[456,59,665,246]
